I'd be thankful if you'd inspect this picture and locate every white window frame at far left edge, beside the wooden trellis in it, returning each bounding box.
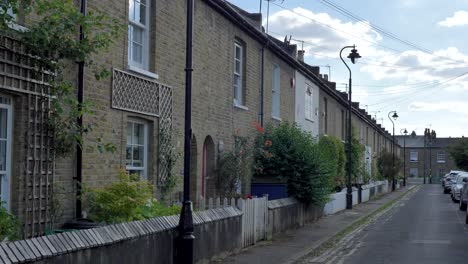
[0,94,13,211]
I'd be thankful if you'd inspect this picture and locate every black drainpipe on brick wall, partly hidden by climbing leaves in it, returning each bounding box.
[75,0,86,218]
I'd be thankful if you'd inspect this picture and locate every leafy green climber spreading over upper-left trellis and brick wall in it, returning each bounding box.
[0,0,124,156]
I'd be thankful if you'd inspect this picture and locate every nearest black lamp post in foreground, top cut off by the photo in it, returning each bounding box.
[175,0,195,264]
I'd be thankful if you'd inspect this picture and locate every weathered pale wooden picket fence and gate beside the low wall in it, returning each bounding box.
[198,196,268,248]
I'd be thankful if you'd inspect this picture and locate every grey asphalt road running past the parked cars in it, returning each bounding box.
[302,184,468,264]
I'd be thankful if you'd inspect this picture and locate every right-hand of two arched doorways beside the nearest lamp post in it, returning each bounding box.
[201,136,216,198]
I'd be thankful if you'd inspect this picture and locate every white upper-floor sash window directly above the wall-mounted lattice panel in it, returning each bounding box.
[128,0,150,70]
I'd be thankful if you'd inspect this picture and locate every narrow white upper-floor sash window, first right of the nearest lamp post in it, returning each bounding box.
[234,41,245,106]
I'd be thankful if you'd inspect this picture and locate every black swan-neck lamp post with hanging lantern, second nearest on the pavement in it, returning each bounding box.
[340,45,361,209]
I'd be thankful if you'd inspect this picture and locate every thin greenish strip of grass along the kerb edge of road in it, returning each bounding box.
[301,187,418,259]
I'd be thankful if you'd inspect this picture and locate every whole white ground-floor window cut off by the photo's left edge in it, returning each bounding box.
[0,95,12,210]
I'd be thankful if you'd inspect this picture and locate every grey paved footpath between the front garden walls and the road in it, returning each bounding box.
[214,185,412,264]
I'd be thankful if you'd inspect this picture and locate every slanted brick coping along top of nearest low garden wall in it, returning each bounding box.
[0,207,242,263]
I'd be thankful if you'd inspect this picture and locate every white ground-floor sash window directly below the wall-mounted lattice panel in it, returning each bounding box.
[126,120,148,179]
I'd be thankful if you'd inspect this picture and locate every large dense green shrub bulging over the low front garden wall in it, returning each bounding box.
[254,122,330,205]
